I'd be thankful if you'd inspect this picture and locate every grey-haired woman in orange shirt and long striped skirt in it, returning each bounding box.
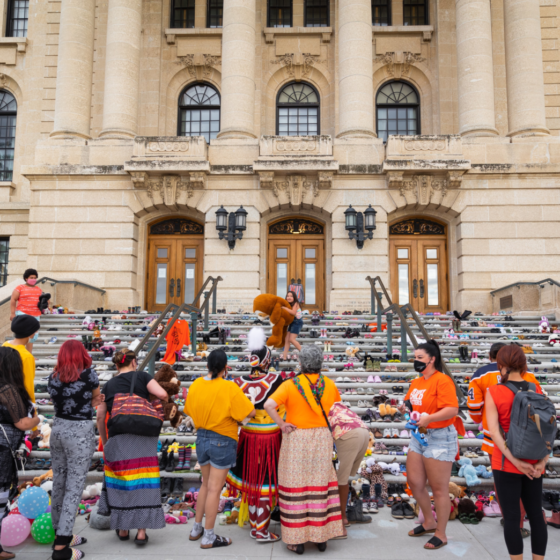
[264,345,343,554]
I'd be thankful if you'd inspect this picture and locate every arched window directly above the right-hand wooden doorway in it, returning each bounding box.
[376,82,420,142]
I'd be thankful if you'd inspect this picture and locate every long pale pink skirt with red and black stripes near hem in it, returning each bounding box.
[278,428,343,544]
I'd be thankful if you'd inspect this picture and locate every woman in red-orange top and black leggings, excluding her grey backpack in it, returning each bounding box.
[484,344,549,560]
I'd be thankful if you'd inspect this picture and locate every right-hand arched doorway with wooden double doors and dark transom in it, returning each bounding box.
[389,218,449,313]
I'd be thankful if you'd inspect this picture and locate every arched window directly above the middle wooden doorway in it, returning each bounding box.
[276,83,319,136]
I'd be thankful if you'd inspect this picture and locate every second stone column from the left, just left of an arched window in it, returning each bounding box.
[99,0,142,138]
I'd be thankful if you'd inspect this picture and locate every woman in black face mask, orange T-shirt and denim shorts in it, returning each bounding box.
[401,340,459,550]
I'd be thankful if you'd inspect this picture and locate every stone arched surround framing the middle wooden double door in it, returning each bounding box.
[259,209,332,311]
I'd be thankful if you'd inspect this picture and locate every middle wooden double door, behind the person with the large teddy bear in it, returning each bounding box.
[267,235,325,312]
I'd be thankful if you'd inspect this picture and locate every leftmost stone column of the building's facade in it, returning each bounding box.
[51,0,95,138]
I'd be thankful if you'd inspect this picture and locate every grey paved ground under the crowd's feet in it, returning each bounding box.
[8,508,560,560]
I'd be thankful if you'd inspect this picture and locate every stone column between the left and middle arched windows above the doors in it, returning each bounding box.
[218,0,256,138]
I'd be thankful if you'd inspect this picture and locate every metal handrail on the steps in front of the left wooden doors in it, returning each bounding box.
[135,276,223,373]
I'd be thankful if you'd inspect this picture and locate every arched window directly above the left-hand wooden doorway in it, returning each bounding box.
[177,84,220,143]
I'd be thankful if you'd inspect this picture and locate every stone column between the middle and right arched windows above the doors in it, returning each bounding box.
[338,0,376,137]
